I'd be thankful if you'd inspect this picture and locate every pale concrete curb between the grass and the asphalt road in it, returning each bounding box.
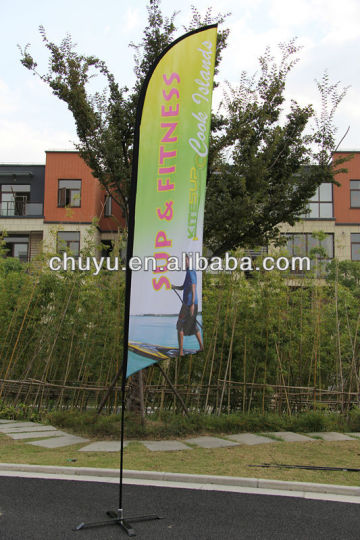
[0,463,360,498]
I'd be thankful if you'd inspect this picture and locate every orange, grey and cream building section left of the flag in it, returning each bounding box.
[0,151,124,262]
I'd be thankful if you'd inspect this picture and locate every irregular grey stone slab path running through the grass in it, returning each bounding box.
[0,419,360,452]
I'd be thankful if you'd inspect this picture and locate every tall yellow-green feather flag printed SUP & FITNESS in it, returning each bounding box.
[125,25,217,377]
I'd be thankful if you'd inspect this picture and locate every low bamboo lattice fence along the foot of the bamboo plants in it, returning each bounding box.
[0,379,360,415]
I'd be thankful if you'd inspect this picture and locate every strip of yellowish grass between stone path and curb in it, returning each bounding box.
[0,434,360,486]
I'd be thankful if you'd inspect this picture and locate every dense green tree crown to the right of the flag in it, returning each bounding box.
[204,39,347,255]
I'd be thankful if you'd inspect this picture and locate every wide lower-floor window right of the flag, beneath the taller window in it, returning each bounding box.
[285,233,334,276]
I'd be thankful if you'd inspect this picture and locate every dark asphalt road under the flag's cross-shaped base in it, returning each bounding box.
[0,477,360,540]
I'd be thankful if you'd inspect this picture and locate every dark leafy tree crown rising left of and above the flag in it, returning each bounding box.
[19,0,228,223]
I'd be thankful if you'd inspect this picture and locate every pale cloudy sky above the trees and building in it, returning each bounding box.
[0,0,360,163]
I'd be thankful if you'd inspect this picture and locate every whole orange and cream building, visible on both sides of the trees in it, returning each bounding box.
[0,151,360,267]
